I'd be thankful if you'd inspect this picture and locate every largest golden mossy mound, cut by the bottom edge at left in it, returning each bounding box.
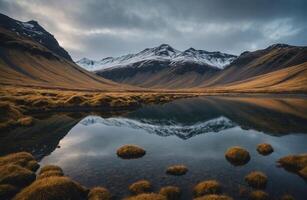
[14,177,88,200]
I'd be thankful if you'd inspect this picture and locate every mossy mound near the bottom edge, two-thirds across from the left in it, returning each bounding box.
[194,180,222,197]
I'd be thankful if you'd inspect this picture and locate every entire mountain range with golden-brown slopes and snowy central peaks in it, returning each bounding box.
[0,14,307,93]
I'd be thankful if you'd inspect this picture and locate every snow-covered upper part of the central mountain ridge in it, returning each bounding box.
[76,44,237,71]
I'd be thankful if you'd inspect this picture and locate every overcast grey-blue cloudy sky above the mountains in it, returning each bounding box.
[0,0,307,60]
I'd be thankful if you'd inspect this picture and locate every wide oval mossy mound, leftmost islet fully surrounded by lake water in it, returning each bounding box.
[116,144,146,159]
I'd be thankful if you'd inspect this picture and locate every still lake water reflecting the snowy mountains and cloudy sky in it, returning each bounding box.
[0,97,307,200]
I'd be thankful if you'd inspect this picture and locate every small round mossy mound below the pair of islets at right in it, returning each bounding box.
[245,171,268,189]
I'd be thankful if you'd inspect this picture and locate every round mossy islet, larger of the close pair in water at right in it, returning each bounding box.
[225,146,250,166]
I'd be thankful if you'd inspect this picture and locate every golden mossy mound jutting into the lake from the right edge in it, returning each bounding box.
[277,154,307,179]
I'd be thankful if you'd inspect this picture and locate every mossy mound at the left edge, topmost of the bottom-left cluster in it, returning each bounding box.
[0,152,39,172]
